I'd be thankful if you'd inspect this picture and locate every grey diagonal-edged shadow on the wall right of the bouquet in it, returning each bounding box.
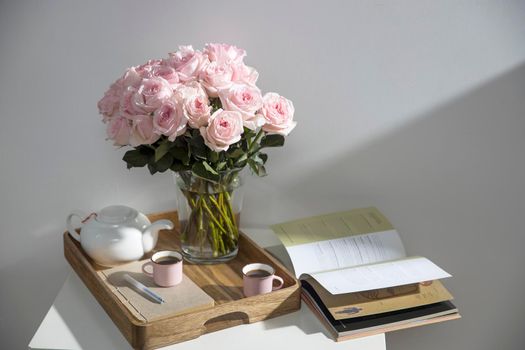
[249,65,525,350]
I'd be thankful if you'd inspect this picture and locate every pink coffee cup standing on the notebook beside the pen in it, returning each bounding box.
[142,250,182,287]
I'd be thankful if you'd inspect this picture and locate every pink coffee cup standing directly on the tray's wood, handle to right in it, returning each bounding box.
[242,263,284,297]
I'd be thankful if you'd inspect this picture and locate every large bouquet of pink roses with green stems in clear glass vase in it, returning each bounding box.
[98,44,296,262]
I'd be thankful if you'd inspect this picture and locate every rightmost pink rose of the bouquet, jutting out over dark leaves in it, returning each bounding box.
[261,92,297,136]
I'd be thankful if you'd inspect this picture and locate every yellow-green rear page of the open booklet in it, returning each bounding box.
[271,208,394,247]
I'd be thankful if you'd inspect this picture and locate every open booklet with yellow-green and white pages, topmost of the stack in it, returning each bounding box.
[272,208,450,294]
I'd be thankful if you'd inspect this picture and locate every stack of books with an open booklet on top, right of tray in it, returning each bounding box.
[272,208,460,341]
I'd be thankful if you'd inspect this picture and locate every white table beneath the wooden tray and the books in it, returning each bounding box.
[29,229,386,350]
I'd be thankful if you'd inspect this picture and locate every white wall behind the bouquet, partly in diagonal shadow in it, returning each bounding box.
[0,0,525,350]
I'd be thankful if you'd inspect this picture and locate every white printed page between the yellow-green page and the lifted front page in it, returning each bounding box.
[287,230,406,278]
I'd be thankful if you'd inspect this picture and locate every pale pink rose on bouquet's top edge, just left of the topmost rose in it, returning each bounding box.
[168,45,208,82]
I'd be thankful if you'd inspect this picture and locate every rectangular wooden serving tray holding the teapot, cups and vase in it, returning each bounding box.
[64,212,301,349]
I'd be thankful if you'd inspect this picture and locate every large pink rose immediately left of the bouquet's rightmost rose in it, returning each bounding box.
[219,84,264,130]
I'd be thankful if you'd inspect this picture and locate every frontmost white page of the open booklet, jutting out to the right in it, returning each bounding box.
[310,257,450,294]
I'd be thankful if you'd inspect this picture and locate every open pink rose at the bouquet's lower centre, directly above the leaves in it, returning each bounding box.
[200,109,243,152]
